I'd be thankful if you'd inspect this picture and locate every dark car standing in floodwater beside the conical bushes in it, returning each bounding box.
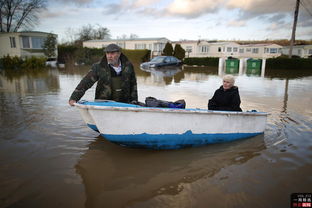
[140,56,182,69]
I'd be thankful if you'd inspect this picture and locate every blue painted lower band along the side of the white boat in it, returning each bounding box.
[101,131,263,149]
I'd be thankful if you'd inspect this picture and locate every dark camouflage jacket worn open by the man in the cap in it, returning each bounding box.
[70,53,138,103]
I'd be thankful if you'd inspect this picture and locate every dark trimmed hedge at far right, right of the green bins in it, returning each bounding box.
[266,57,312,70]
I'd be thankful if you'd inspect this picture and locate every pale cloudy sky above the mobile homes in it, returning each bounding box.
[34,0,312,41]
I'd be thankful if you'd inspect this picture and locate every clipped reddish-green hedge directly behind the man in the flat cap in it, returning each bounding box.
[58,45,151,65]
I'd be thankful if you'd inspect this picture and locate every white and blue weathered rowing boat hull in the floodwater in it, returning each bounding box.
[77,102,267,149]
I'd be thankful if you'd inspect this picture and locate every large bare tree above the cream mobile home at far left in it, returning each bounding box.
[0,0,47,32]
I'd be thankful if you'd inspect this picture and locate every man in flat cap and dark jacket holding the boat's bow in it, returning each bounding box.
[69,44,138,106]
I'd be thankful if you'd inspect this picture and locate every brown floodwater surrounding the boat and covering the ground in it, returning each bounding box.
[0,64,312,208]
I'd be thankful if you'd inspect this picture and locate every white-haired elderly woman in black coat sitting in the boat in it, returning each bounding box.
[208,75,242,111]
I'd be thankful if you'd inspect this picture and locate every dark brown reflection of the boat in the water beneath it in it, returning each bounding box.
[76,135,266,207]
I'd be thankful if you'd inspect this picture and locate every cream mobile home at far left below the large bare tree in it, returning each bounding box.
[0,31,57,58]
